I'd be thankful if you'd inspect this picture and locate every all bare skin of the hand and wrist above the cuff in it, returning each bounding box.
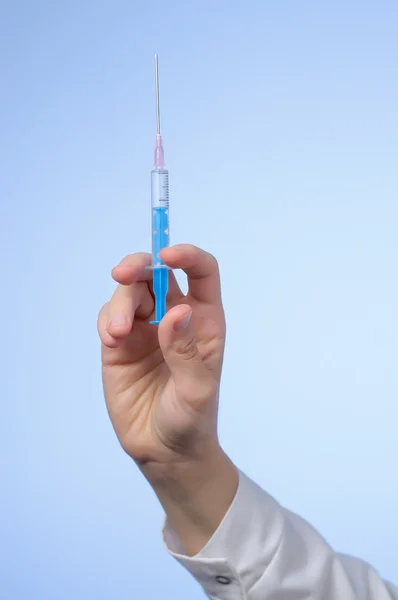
[98,245,238,556]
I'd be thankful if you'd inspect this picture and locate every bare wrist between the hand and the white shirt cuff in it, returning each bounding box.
[144,449,239,556]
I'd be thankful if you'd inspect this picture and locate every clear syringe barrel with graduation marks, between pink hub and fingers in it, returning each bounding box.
[151,168,169,267]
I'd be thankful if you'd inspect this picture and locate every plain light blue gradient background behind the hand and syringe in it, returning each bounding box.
[0,0,398,600]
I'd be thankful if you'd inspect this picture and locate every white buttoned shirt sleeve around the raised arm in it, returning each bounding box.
[163,472,398,600]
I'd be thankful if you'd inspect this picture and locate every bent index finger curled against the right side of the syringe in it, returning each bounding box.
[161,244,221,304]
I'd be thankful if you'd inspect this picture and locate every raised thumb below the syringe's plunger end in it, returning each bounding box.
[158,304,209,393]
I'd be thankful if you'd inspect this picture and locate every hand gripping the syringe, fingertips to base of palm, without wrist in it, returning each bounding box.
[98,245,225,465]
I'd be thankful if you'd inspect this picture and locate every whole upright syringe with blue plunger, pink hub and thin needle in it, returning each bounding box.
[151,54,169,325]
